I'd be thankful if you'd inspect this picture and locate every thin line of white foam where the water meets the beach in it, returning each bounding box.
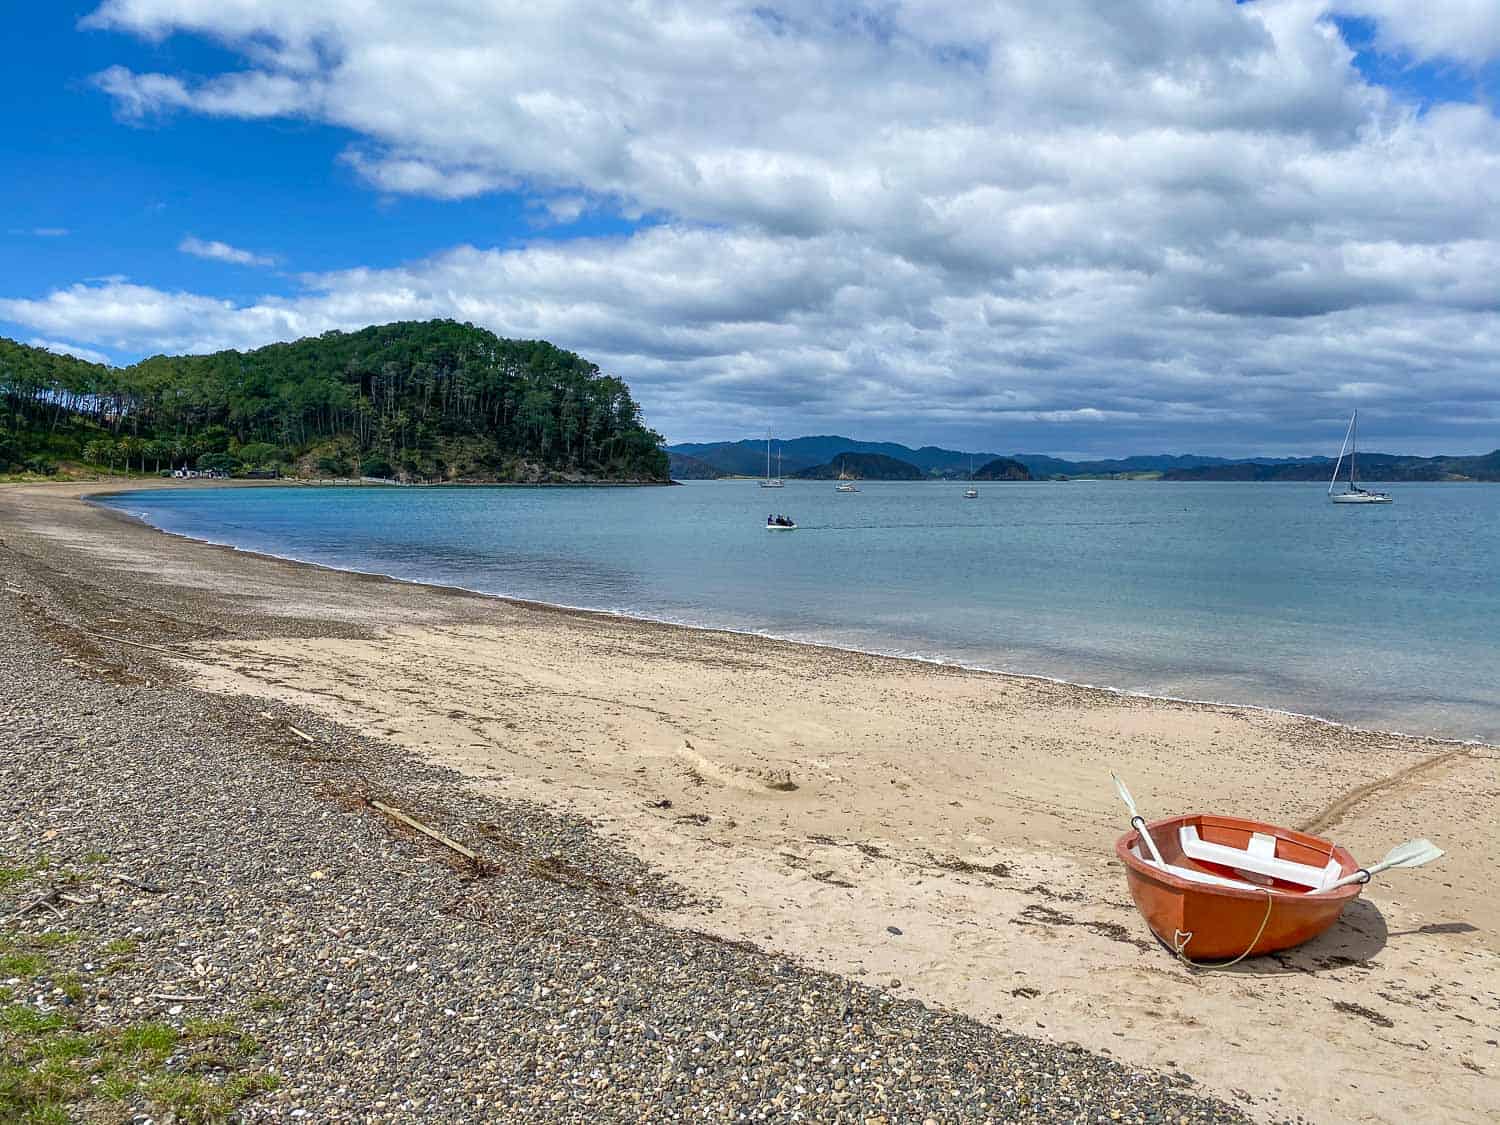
[81,494,1490,747]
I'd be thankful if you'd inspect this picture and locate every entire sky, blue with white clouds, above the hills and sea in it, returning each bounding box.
[0,0,1500,456]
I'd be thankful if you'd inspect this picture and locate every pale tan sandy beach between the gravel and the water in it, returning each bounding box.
[0,485,1500,1122]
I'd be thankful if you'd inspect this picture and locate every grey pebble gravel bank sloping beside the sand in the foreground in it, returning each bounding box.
[0,495,1245,1125]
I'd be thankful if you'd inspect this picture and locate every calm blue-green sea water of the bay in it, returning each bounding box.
[99,482,1500,741]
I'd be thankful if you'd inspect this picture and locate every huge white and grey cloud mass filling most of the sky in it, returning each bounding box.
[0,0,1500,449]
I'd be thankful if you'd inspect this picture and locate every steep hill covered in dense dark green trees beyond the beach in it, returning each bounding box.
[0,321,668,480]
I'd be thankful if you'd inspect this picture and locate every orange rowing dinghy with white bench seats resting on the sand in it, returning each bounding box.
[1115,813,1370,962]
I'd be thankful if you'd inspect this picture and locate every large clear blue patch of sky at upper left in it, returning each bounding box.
[0,3,635,310]
